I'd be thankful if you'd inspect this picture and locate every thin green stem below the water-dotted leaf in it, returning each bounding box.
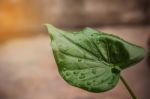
[120,76,137,99]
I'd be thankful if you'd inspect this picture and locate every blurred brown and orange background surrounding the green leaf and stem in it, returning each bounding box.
[0,0,150,99]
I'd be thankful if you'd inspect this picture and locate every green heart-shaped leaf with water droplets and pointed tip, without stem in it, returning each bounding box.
[46,24,144,92]
